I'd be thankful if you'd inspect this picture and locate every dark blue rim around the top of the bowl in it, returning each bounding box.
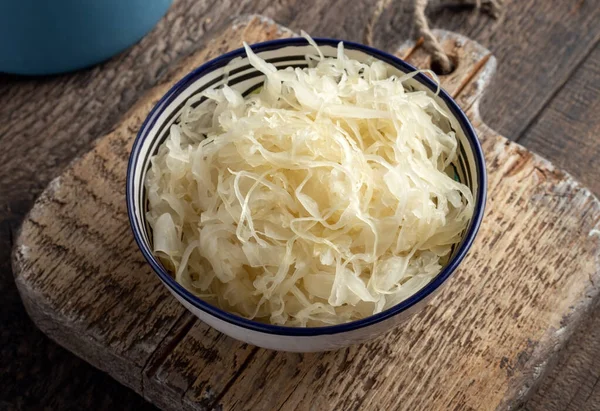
[126,37,487,336]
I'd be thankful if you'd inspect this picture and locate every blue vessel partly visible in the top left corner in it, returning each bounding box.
[0,0,172,75]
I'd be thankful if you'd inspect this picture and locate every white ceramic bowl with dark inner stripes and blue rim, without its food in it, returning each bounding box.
[127,38,486,352]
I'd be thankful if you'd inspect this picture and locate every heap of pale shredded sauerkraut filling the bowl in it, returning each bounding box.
[145,36,473,327]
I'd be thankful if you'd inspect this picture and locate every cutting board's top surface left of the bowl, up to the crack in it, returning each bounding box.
[9,16,296,392]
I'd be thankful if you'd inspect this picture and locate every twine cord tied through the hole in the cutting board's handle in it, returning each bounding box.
[414,0,502,74]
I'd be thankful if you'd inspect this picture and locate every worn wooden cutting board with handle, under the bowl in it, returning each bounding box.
[13,16,600,410]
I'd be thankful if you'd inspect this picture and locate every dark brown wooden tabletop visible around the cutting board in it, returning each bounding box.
[0,0,600,410]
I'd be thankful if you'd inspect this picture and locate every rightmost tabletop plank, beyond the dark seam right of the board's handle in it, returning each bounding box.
[521,38,600,411]
